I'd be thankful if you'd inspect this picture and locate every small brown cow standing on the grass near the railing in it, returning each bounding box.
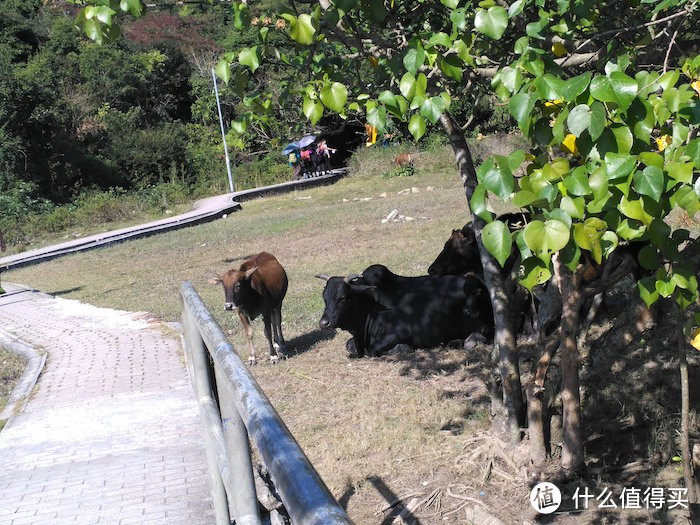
[216,252,288,365]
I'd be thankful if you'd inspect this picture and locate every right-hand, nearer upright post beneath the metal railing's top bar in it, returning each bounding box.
[214,366,261,525]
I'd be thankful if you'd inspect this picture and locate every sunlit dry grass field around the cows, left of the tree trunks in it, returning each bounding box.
[3,140,696,524]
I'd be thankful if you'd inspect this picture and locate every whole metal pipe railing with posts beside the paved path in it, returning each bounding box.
[180,281,352,525]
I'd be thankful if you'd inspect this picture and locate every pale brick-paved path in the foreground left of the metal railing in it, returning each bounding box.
[0,283,214,525]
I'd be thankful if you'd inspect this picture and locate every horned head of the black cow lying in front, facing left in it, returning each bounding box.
[316,275,375,330]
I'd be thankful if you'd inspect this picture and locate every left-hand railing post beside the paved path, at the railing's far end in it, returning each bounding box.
[182,301,231,525]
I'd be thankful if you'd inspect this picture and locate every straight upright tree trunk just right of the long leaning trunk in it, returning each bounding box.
[553,254,583,473]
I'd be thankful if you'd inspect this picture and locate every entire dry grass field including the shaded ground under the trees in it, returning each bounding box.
[3,142,700,524]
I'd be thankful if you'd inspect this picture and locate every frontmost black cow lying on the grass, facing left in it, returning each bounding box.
[317,264,493,357]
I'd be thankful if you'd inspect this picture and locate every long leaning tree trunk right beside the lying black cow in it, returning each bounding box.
[440,113,525,444]
